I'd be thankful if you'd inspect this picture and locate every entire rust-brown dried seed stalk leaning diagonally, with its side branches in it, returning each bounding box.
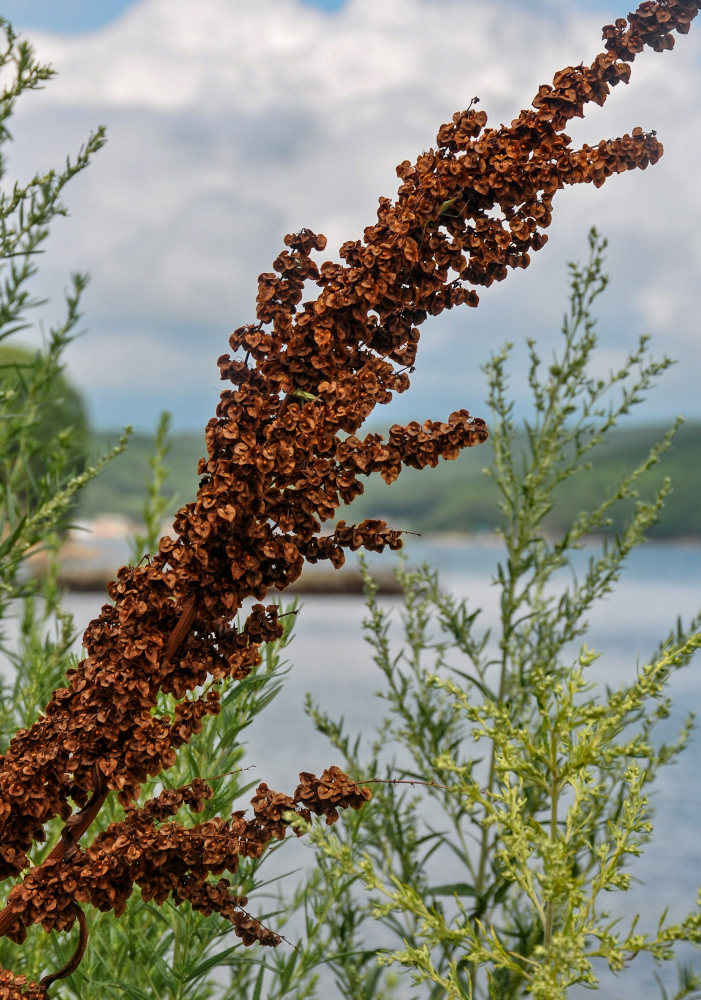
[0,0,701,984]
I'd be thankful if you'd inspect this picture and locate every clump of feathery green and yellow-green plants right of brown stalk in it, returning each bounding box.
[271,232,701,1000]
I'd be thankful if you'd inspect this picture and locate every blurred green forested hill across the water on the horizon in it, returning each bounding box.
[79,423,701,538]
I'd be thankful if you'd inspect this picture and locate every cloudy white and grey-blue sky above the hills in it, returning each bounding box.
[5,0,701,429]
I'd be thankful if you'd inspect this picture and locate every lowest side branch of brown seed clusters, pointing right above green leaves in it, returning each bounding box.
[6,767,370,945]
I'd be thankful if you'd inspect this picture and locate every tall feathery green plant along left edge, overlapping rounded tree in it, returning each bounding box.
[0,20,125,742]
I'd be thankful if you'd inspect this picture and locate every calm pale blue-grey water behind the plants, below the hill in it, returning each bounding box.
[12,540,701,1000]
